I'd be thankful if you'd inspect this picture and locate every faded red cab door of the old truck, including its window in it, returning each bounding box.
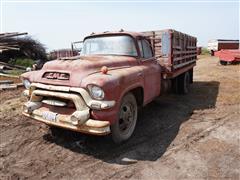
[138,39,161,103]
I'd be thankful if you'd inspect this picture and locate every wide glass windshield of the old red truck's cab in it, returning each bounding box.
[81,35,137,56]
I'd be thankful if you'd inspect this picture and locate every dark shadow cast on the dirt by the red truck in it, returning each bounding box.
[43,81,219,164]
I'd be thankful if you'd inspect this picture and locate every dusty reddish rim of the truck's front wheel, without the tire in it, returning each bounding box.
[119,102,136,134]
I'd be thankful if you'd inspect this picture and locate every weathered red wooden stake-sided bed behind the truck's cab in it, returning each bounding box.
[142,29,197,78]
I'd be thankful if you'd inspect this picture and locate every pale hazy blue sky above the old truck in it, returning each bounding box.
[0,0,239,51]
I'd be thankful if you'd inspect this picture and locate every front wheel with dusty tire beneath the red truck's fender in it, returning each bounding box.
[111,93,138,144]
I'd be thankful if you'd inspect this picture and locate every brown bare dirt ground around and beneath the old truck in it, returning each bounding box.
[0,56,240,180]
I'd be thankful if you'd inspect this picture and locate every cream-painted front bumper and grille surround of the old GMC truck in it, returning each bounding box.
[23,83,115,135]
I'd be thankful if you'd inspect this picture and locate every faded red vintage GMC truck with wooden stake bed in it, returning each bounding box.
[21,29,197,143]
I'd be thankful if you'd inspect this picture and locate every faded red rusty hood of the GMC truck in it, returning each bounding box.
[22,56,137,87]
